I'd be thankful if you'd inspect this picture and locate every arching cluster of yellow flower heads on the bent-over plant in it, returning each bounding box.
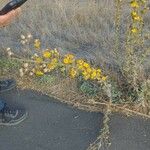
[20,39,107,81]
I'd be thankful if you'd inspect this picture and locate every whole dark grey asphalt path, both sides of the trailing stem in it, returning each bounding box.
[0,88,150,150]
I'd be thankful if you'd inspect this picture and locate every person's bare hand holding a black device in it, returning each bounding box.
[0,8,21,27]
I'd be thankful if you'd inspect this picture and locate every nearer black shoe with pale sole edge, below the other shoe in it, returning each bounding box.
[0,107,27,126]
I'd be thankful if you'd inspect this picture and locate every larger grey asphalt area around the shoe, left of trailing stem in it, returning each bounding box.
[0,90,103,150]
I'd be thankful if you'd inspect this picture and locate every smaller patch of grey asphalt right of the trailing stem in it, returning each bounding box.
[110,115,150,150]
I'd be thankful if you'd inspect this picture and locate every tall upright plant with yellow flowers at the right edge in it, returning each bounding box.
[120,0,149,102]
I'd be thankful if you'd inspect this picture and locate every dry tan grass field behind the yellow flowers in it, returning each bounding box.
[0,0,150,73]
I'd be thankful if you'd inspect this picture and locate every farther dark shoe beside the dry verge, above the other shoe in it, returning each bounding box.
[0,79,16,93]
